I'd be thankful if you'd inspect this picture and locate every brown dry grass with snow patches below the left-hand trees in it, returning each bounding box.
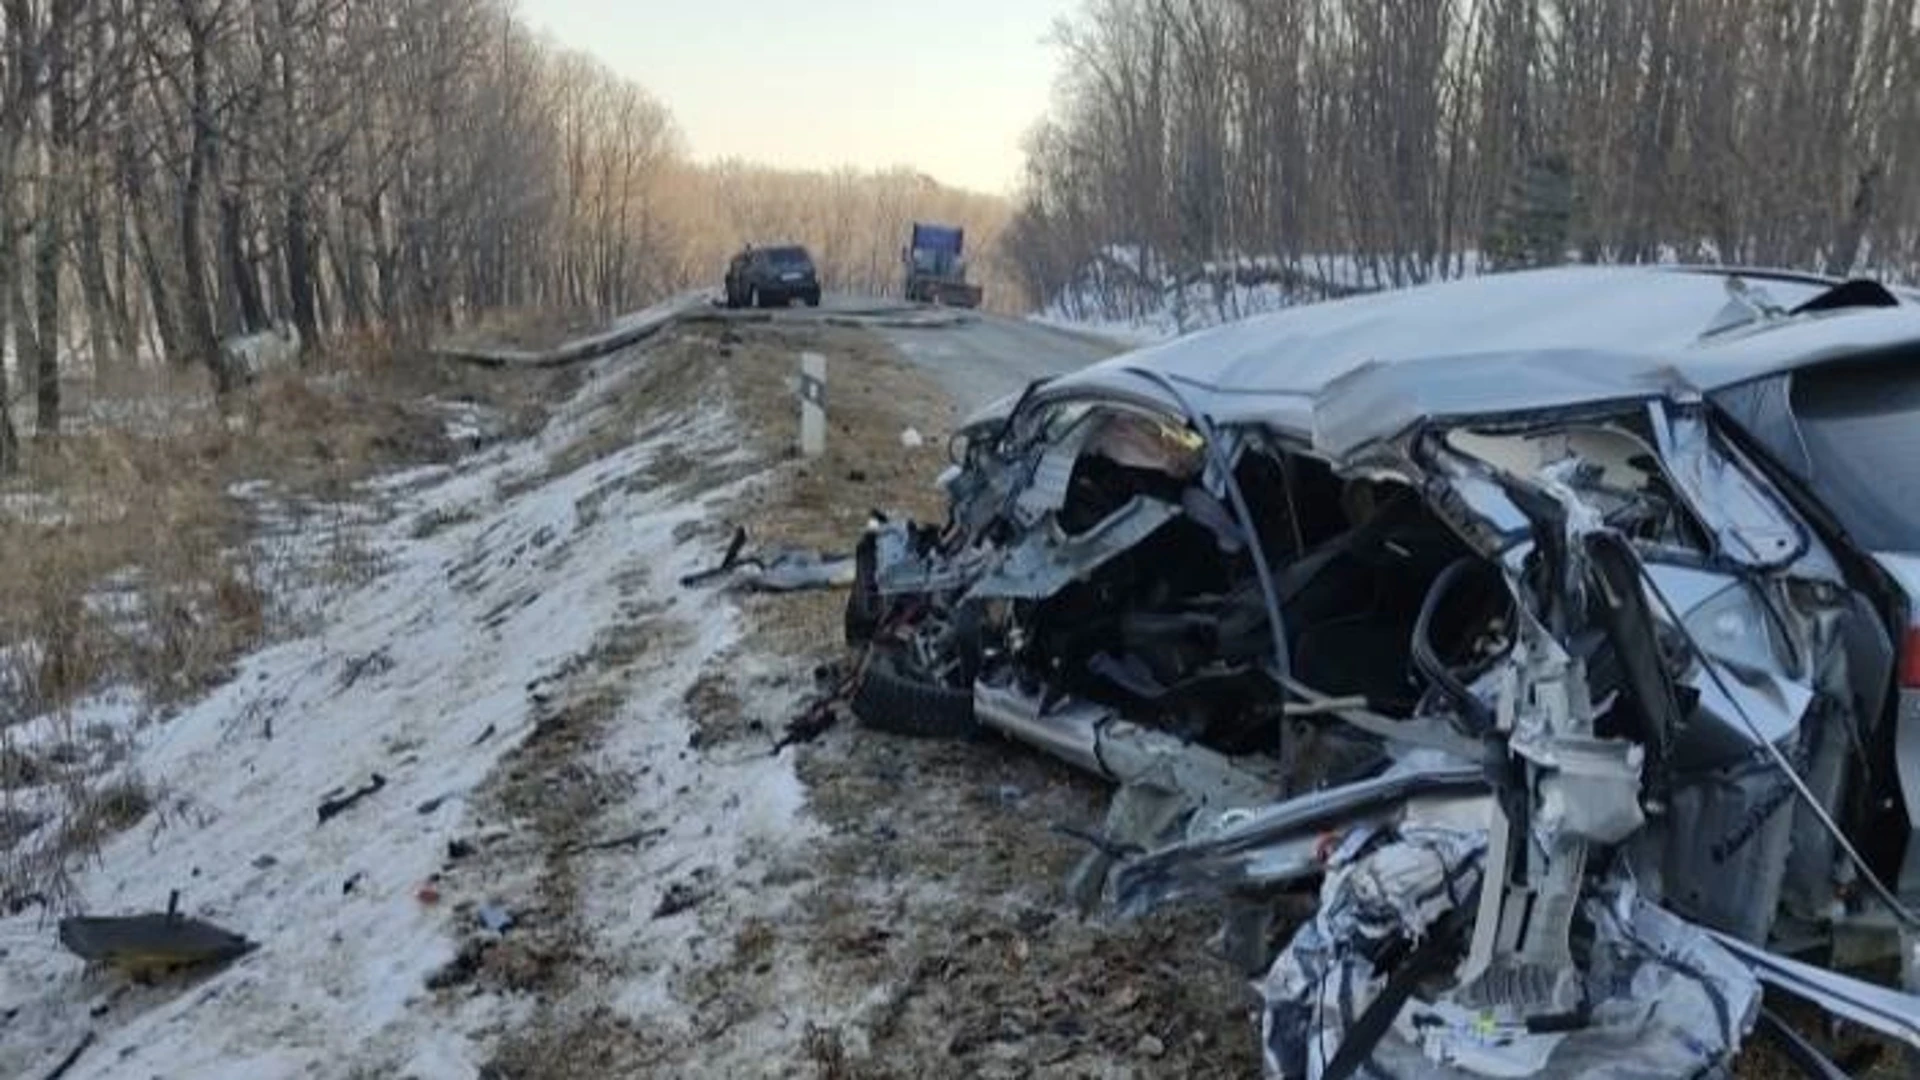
[0,338,568,905]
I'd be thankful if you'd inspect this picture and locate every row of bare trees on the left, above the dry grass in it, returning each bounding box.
[0,0,676,457]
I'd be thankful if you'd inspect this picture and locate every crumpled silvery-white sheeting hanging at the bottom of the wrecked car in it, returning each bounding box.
[1261,849,1761,1080]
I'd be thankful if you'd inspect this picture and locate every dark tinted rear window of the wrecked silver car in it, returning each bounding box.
[1793,356,1920,552]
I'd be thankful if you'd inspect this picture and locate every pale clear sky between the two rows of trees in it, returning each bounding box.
[520,0,1077,192]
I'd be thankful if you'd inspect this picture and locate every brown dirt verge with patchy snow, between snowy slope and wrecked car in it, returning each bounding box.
[438,315,1258,1080]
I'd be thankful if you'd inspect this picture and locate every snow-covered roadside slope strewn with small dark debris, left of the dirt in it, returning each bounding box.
[0,340,804,1080]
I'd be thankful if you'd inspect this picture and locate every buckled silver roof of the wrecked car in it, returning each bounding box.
[1044,267,1920,457]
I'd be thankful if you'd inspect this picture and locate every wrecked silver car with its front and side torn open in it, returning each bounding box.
[847,269,1920,1080]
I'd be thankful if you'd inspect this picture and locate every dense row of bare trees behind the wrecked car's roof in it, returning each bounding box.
[1006,0,1920,315]
